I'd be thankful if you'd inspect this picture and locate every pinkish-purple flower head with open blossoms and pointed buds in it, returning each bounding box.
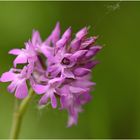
[1,23,101,126]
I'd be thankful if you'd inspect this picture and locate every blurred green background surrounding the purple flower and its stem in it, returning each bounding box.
[0,2,140,139]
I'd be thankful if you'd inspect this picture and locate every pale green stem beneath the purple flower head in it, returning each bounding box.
[10,89,34,139]
